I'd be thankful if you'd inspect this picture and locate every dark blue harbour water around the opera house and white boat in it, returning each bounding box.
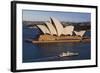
[22,26,91,63]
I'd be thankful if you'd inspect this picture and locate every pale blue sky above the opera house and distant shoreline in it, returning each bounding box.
[22,10,91,22]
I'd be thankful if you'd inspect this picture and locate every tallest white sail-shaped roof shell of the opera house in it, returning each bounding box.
[50,17,63,36]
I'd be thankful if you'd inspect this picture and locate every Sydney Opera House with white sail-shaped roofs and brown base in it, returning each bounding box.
[31,17,86,41]
